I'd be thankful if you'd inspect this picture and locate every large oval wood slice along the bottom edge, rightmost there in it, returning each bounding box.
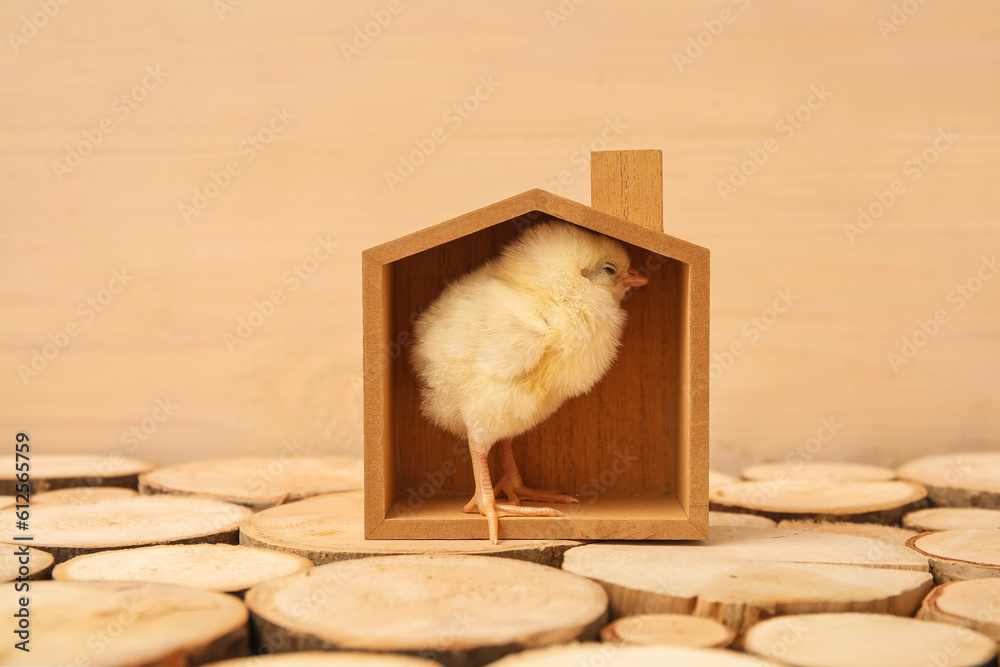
[744,614,997,667]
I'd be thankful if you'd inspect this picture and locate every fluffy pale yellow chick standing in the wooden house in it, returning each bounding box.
[412,222,649,544]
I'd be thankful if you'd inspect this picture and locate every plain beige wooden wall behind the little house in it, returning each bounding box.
[0,0,1000,470]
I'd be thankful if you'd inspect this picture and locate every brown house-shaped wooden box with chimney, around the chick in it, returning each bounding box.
[362,151,709,540]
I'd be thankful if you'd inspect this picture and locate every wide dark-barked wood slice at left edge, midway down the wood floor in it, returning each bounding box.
[0,496,252,563]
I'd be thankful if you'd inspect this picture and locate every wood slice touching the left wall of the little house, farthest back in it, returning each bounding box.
[139,456,364,510]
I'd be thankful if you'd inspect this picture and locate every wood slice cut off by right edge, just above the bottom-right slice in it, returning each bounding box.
[917,578,1000,642]
